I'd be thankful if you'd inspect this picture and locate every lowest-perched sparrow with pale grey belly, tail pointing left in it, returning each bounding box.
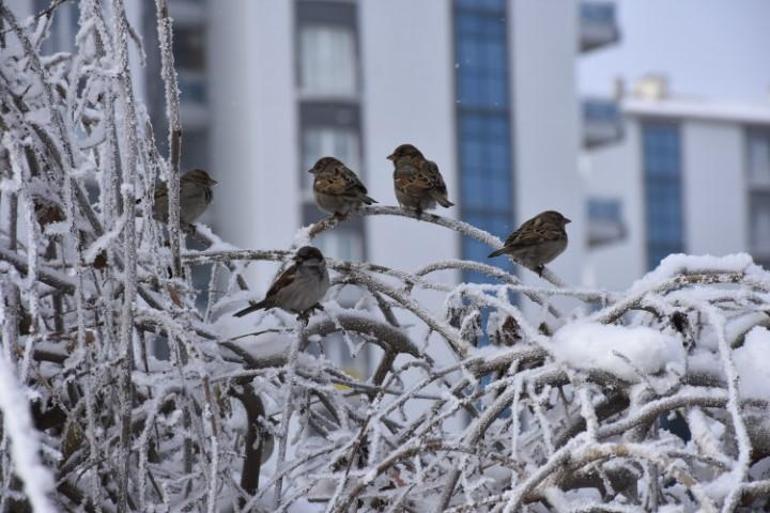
[233,246,329,319]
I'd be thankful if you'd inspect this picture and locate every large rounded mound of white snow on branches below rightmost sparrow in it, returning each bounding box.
[552,321,685,383]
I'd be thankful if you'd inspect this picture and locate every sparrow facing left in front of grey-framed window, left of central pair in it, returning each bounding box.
[308,157,377,217]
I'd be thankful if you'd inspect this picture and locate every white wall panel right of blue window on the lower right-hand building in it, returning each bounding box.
[682,120,748,255]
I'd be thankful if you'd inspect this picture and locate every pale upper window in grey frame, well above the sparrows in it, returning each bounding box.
[300,25,356,96]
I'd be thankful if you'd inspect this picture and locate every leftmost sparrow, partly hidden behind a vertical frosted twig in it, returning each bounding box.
[152,169,217,226]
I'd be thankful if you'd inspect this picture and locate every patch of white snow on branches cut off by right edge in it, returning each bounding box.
[733,327,770,401]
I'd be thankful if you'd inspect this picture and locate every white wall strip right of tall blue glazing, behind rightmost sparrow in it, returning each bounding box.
[510,0,586,290]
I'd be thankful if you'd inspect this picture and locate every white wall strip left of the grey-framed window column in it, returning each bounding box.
[207,0,300,282]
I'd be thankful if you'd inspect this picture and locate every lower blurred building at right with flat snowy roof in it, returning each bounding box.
[584,87,770,289]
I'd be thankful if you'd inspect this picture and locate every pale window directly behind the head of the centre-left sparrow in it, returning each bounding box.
[302,127,363,201]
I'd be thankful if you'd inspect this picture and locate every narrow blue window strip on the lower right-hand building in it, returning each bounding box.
[642,121,684,269]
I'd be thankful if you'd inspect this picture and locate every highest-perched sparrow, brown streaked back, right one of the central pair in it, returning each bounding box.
[387,144,454,218]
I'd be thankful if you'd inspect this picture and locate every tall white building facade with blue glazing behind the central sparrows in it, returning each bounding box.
[207,0,596,296]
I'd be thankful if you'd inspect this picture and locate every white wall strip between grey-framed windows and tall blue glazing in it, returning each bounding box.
[359,0,459,280]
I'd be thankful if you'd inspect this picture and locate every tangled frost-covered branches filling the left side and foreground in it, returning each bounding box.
[0,0,770,513]
